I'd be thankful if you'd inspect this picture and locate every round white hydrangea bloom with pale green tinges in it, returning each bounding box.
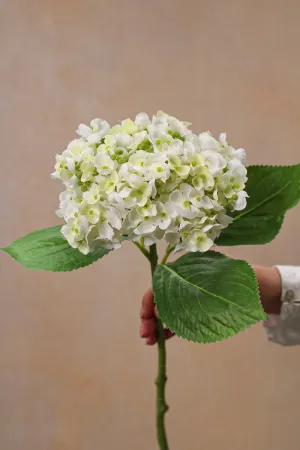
[52,111,248,254]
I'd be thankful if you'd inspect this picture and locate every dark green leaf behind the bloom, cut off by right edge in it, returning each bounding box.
[216,164,300,245]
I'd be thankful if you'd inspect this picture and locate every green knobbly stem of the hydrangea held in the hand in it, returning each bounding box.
[150,244,172,450]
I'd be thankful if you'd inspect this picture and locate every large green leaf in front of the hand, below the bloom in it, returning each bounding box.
[153,252,267,343]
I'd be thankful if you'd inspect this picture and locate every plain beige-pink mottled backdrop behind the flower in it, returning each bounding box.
[0,0,300,450]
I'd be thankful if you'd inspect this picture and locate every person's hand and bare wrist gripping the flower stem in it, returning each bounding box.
[140,265,281,345]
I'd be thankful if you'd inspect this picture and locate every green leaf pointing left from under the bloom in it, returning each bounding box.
[1,226,110,272]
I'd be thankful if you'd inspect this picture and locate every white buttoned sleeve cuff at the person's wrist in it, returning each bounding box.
[264,266,300,346]
